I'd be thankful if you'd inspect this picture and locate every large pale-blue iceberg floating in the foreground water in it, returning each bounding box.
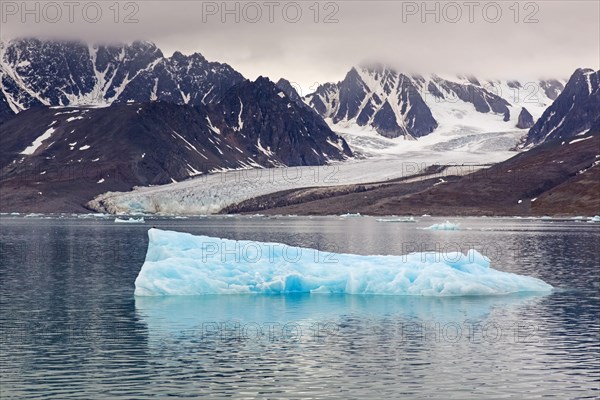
[135,229,552,296]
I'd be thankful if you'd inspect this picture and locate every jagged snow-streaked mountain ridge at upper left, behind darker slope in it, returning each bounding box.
[0,39,244,119]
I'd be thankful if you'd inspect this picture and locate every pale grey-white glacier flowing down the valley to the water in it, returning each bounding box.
[88,127,525,215]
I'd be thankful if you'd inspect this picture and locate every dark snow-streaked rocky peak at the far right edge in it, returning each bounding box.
[524,68,600,146]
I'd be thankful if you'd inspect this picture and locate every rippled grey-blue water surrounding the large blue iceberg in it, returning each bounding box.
[0,216,600,399]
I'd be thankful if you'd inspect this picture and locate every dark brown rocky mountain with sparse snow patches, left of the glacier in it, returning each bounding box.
[0,78,351,212]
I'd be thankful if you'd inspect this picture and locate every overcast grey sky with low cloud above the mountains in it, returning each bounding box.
[0,0,600,95]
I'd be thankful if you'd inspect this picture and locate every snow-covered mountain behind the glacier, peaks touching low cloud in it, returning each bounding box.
[304,65,563,138]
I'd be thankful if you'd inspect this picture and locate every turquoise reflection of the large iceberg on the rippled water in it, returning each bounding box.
[135,294,546,350]
